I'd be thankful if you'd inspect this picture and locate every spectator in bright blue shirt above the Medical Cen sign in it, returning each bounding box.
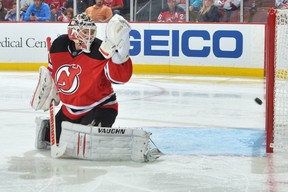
[24,0,51,21]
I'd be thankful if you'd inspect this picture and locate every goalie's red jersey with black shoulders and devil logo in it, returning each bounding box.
[48,35,132,120]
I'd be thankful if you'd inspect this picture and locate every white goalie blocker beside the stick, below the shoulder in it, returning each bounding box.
[30,66,60,111]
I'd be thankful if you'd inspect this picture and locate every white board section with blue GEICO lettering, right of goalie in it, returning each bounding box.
[130,24,265,68]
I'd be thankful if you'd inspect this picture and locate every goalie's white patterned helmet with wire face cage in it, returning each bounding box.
[68,13,97,53]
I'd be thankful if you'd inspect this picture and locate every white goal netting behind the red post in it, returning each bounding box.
[271,10,288,151]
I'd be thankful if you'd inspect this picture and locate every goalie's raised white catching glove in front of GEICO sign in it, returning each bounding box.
[99,14,131,64]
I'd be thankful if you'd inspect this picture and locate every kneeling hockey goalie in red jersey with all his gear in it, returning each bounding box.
[31,13,161,162]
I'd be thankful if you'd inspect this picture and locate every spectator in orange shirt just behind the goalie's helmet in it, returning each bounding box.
[85,0,113,22]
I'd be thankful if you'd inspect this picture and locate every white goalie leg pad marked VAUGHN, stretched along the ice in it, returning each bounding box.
[60,121,160,162]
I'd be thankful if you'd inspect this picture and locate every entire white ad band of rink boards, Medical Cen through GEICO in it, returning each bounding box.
[0,23,264,68]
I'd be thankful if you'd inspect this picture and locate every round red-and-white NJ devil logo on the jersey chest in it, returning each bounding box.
[55,64,82,94]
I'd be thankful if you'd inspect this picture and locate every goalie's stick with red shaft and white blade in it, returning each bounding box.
[46,37,67,158]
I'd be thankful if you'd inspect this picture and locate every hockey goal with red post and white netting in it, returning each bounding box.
[265,8,288,153]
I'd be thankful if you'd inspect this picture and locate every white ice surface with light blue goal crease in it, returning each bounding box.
[0,72,288,192]
